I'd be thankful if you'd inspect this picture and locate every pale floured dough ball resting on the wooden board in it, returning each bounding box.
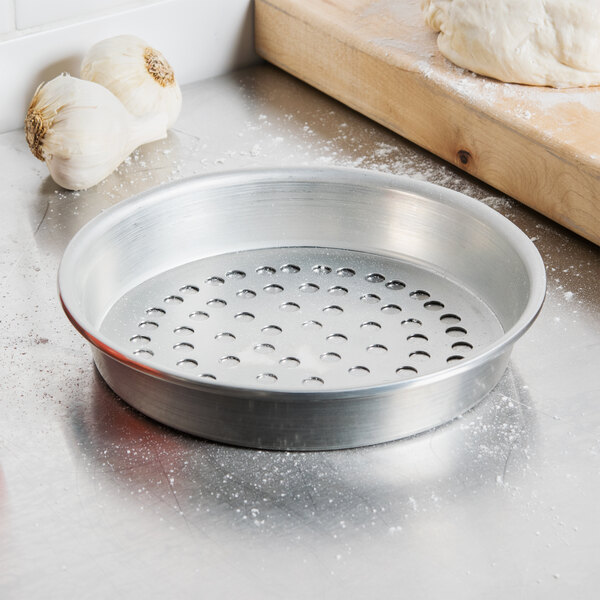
[421,0,600,87]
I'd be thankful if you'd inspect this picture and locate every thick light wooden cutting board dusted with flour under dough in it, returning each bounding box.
[255,0,600,244]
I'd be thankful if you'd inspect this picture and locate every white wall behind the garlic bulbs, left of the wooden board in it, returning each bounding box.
[0,0,258,132]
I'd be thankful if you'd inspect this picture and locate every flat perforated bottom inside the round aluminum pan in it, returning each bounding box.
[100,247,504,391]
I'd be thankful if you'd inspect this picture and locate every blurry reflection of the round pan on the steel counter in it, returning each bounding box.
[62,358,537,536]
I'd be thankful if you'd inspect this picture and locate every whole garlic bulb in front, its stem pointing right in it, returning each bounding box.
[25,73,167,190]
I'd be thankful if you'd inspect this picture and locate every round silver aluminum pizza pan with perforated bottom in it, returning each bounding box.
[59,169,545,449]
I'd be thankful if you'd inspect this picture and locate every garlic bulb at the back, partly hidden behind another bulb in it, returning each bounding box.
[81,35,181,128]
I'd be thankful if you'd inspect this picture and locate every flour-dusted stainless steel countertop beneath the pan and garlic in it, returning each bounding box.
[0,66,600,600]
